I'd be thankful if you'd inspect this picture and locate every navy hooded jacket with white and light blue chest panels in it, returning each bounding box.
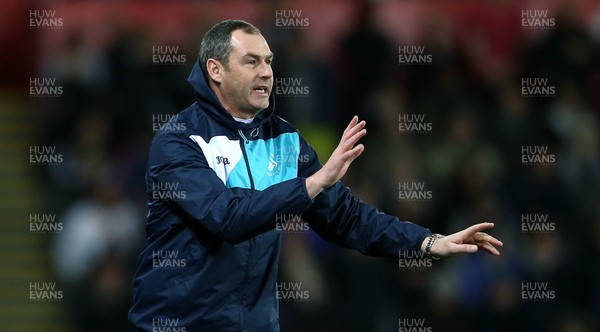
[129,58,431,332]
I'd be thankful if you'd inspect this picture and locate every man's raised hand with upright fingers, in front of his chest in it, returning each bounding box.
[306,116,367,198]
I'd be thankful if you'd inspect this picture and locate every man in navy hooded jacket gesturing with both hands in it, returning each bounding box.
[129,20,502,331]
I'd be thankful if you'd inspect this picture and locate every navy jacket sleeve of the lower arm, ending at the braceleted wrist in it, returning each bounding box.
[300,135,431,257]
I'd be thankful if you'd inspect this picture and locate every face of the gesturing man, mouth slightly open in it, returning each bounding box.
[212,30,273,118]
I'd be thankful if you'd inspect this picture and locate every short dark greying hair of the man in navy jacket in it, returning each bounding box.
[198,20,260,76]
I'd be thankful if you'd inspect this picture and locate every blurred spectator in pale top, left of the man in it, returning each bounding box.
[53,163,144,331]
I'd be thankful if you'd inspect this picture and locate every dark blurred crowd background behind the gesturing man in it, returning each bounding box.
[0,0,600,332]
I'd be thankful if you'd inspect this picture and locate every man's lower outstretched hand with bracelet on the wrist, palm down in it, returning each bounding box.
[421,222,503,257]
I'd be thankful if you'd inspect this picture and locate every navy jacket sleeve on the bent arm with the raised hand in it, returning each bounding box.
[146,131,312,243]
